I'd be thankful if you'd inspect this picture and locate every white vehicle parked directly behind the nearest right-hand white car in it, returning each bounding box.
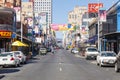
[85,47,99,59]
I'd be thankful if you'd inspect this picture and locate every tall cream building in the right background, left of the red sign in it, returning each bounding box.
[66,6,88,47]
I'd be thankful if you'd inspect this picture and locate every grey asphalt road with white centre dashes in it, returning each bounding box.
[0,50,120,80]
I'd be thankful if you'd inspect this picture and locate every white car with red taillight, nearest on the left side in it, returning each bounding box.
[0,52,20,67]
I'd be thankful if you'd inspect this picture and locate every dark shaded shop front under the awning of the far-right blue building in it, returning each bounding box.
[102,32,120,53]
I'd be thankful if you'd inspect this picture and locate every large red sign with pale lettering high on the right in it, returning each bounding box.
[88,3,103,13]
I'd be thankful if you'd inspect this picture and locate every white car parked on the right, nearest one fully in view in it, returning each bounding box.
[97,51,116,66]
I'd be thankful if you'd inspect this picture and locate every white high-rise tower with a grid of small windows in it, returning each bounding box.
[34,0,52,33]
